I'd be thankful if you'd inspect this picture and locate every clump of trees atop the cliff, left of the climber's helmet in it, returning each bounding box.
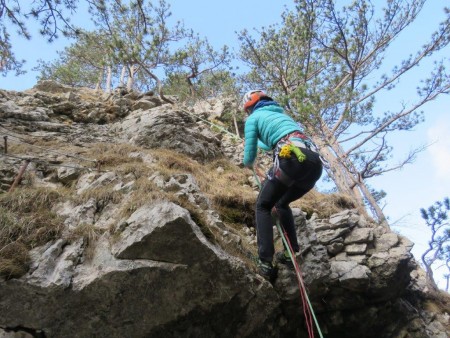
[32,0,231,97]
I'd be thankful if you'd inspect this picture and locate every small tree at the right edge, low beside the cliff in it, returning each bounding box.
[420,197,450,291]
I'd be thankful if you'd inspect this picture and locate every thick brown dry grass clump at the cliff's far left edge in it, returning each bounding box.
[0,188,62,278]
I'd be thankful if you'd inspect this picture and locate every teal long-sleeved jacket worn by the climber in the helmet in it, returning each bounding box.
[244,101,300,168]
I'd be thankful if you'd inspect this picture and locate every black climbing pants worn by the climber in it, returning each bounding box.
[256,148,322,262]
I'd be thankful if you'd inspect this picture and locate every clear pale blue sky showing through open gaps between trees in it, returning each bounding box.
[0,0,450,286]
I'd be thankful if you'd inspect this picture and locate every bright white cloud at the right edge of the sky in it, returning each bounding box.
[427,119,450,180]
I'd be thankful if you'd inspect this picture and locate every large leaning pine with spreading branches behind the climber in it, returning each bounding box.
[239,0,450,221]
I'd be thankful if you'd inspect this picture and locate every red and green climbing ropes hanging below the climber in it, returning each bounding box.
[253,168,323,338]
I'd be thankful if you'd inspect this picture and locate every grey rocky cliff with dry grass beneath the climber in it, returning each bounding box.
[0,82,450,338]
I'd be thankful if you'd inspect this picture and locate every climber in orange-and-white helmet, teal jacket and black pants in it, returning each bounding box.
[243,90,322,281]
